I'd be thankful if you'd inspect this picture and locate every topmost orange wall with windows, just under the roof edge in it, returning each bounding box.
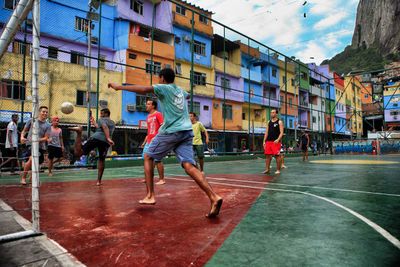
[172,2,214,35]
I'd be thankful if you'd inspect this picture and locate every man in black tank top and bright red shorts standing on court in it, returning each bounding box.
[263,108,283,174]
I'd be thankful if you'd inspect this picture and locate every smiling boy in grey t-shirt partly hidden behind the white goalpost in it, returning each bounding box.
[21,106,50,185]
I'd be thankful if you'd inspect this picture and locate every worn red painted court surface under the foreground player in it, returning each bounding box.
[0,174,271,266]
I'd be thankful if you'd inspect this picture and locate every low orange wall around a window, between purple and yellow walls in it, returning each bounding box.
[212,99,242,131]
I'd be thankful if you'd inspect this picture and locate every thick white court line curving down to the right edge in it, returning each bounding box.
[169,178,400,249]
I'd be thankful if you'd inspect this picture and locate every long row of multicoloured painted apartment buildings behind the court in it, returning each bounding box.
[0,0,398,173]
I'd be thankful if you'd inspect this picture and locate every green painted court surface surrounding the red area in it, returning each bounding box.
[0,155,400,266]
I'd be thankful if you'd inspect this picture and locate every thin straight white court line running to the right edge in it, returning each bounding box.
[171,174,400,197]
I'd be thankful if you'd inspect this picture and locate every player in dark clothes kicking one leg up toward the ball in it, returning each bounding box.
[69,108,115,186]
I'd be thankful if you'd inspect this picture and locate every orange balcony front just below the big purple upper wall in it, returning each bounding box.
[129,34,175,60]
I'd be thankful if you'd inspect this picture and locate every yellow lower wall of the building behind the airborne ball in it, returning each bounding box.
[0,53,124,124]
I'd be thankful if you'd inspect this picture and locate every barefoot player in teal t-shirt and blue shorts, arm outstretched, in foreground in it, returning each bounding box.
[108,68,222,218]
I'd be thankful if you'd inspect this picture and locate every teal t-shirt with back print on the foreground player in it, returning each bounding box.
[153,83,192,134]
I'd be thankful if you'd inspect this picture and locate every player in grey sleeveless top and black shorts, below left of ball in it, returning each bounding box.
[47,117,64,176]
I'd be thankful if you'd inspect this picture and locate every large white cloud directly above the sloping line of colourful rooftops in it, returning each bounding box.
[202,0,304,48]
